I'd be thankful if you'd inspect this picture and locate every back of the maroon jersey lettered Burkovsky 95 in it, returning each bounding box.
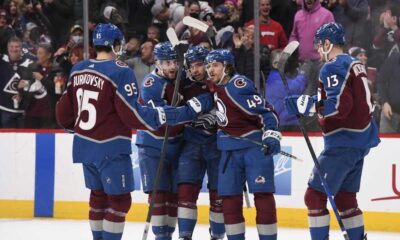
[70,60,131,141]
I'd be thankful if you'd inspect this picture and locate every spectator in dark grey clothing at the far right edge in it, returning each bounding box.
[378,52,400,133]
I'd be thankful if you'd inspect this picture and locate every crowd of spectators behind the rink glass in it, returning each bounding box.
[0,0,400,133]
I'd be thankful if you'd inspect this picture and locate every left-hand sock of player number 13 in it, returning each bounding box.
[304,188,330,240]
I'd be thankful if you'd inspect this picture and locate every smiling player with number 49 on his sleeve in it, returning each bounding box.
[205,49,282,240]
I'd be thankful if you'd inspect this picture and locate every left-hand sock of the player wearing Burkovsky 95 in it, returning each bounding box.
[89,190,108,240]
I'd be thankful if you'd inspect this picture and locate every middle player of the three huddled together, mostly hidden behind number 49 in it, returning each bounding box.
[178,46,225,240]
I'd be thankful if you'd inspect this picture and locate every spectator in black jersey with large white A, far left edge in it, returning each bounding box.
[0,37,32,128]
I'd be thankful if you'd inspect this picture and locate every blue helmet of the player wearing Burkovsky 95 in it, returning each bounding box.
[93,23,124,47]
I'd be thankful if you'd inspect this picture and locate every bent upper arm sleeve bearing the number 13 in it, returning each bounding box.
[318,65,354,119]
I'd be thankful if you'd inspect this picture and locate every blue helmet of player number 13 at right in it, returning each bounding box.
[314,22,346,45]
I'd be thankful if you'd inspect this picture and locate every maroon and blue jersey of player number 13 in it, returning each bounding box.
[319,54,379,150]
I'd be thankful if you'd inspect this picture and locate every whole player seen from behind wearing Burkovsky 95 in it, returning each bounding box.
[56,24,212,240]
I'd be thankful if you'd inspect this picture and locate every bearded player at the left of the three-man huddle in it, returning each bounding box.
[136,42,188,240]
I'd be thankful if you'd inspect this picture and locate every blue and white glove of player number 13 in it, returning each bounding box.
[285,95,318,116]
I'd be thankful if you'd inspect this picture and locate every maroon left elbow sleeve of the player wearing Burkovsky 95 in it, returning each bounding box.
[56,82,75,130]
